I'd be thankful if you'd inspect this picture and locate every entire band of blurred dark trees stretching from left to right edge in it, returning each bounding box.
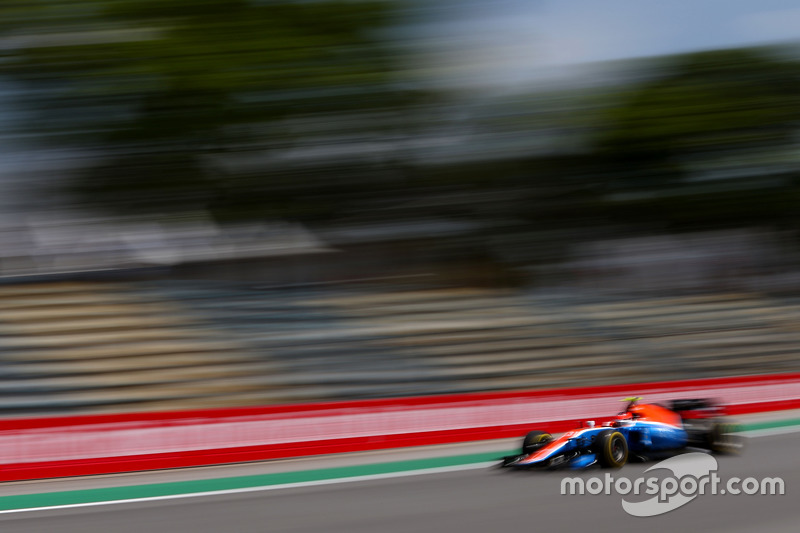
[0,5,800,237]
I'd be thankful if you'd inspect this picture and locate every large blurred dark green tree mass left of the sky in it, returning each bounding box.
[0,0,422,218]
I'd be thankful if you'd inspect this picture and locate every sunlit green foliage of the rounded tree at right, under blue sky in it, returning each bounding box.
[596,49,800,206]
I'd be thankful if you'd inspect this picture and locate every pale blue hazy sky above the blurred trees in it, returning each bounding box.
[419,0,800,89]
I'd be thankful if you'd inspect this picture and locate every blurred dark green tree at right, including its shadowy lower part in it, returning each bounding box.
[593,49,800,229]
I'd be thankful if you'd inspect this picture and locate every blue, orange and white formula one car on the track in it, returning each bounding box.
[502,398,742,468]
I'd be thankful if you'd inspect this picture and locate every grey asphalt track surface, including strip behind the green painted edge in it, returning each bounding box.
[0,427,800,533]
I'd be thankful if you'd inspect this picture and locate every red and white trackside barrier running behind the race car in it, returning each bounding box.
[0,373,800,481]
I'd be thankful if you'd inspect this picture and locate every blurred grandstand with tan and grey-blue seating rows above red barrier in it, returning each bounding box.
[0,280,800,415]
